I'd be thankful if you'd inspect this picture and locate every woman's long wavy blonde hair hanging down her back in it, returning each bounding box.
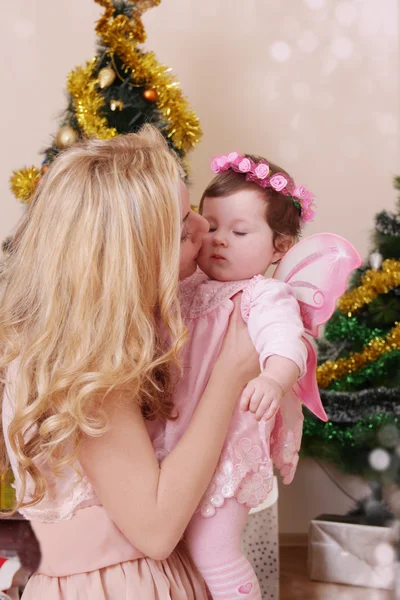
[0,125,185,509]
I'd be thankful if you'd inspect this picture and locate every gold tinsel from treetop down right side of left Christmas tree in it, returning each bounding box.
[95,0,201,152]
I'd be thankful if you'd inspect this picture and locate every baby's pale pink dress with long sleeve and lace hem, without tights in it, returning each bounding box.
[154,270,307,517]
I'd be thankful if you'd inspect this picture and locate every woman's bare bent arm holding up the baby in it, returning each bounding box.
[80,304,259,560]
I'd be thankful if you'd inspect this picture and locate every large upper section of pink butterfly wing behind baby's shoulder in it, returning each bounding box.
[274,233,361,337]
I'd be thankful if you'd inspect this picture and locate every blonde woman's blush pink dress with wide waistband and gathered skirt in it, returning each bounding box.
[2,366,208,600]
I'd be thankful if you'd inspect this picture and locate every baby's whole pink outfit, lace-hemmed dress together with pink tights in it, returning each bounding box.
[154,271,307,600]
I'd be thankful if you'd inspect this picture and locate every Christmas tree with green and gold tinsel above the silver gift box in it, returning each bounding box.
[303,177,400,502]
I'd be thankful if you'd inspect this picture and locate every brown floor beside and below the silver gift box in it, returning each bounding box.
[280,546,393,600]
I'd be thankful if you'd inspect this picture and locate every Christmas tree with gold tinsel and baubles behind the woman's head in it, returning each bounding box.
[11,0,201,202]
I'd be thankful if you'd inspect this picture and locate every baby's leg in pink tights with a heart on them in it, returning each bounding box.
[185,498,261,600]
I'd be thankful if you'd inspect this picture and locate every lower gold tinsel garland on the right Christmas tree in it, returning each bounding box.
[317,323,400,388]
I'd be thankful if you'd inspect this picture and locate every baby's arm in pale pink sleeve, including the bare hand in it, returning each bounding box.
[240,279,307,420]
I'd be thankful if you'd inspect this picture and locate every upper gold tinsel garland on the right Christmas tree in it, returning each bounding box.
[338,258,400,316]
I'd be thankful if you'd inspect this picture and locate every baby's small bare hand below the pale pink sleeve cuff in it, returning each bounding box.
[240,374,283,421]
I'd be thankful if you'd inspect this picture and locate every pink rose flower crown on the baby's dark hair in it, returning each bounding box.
[211,152,315,223]
